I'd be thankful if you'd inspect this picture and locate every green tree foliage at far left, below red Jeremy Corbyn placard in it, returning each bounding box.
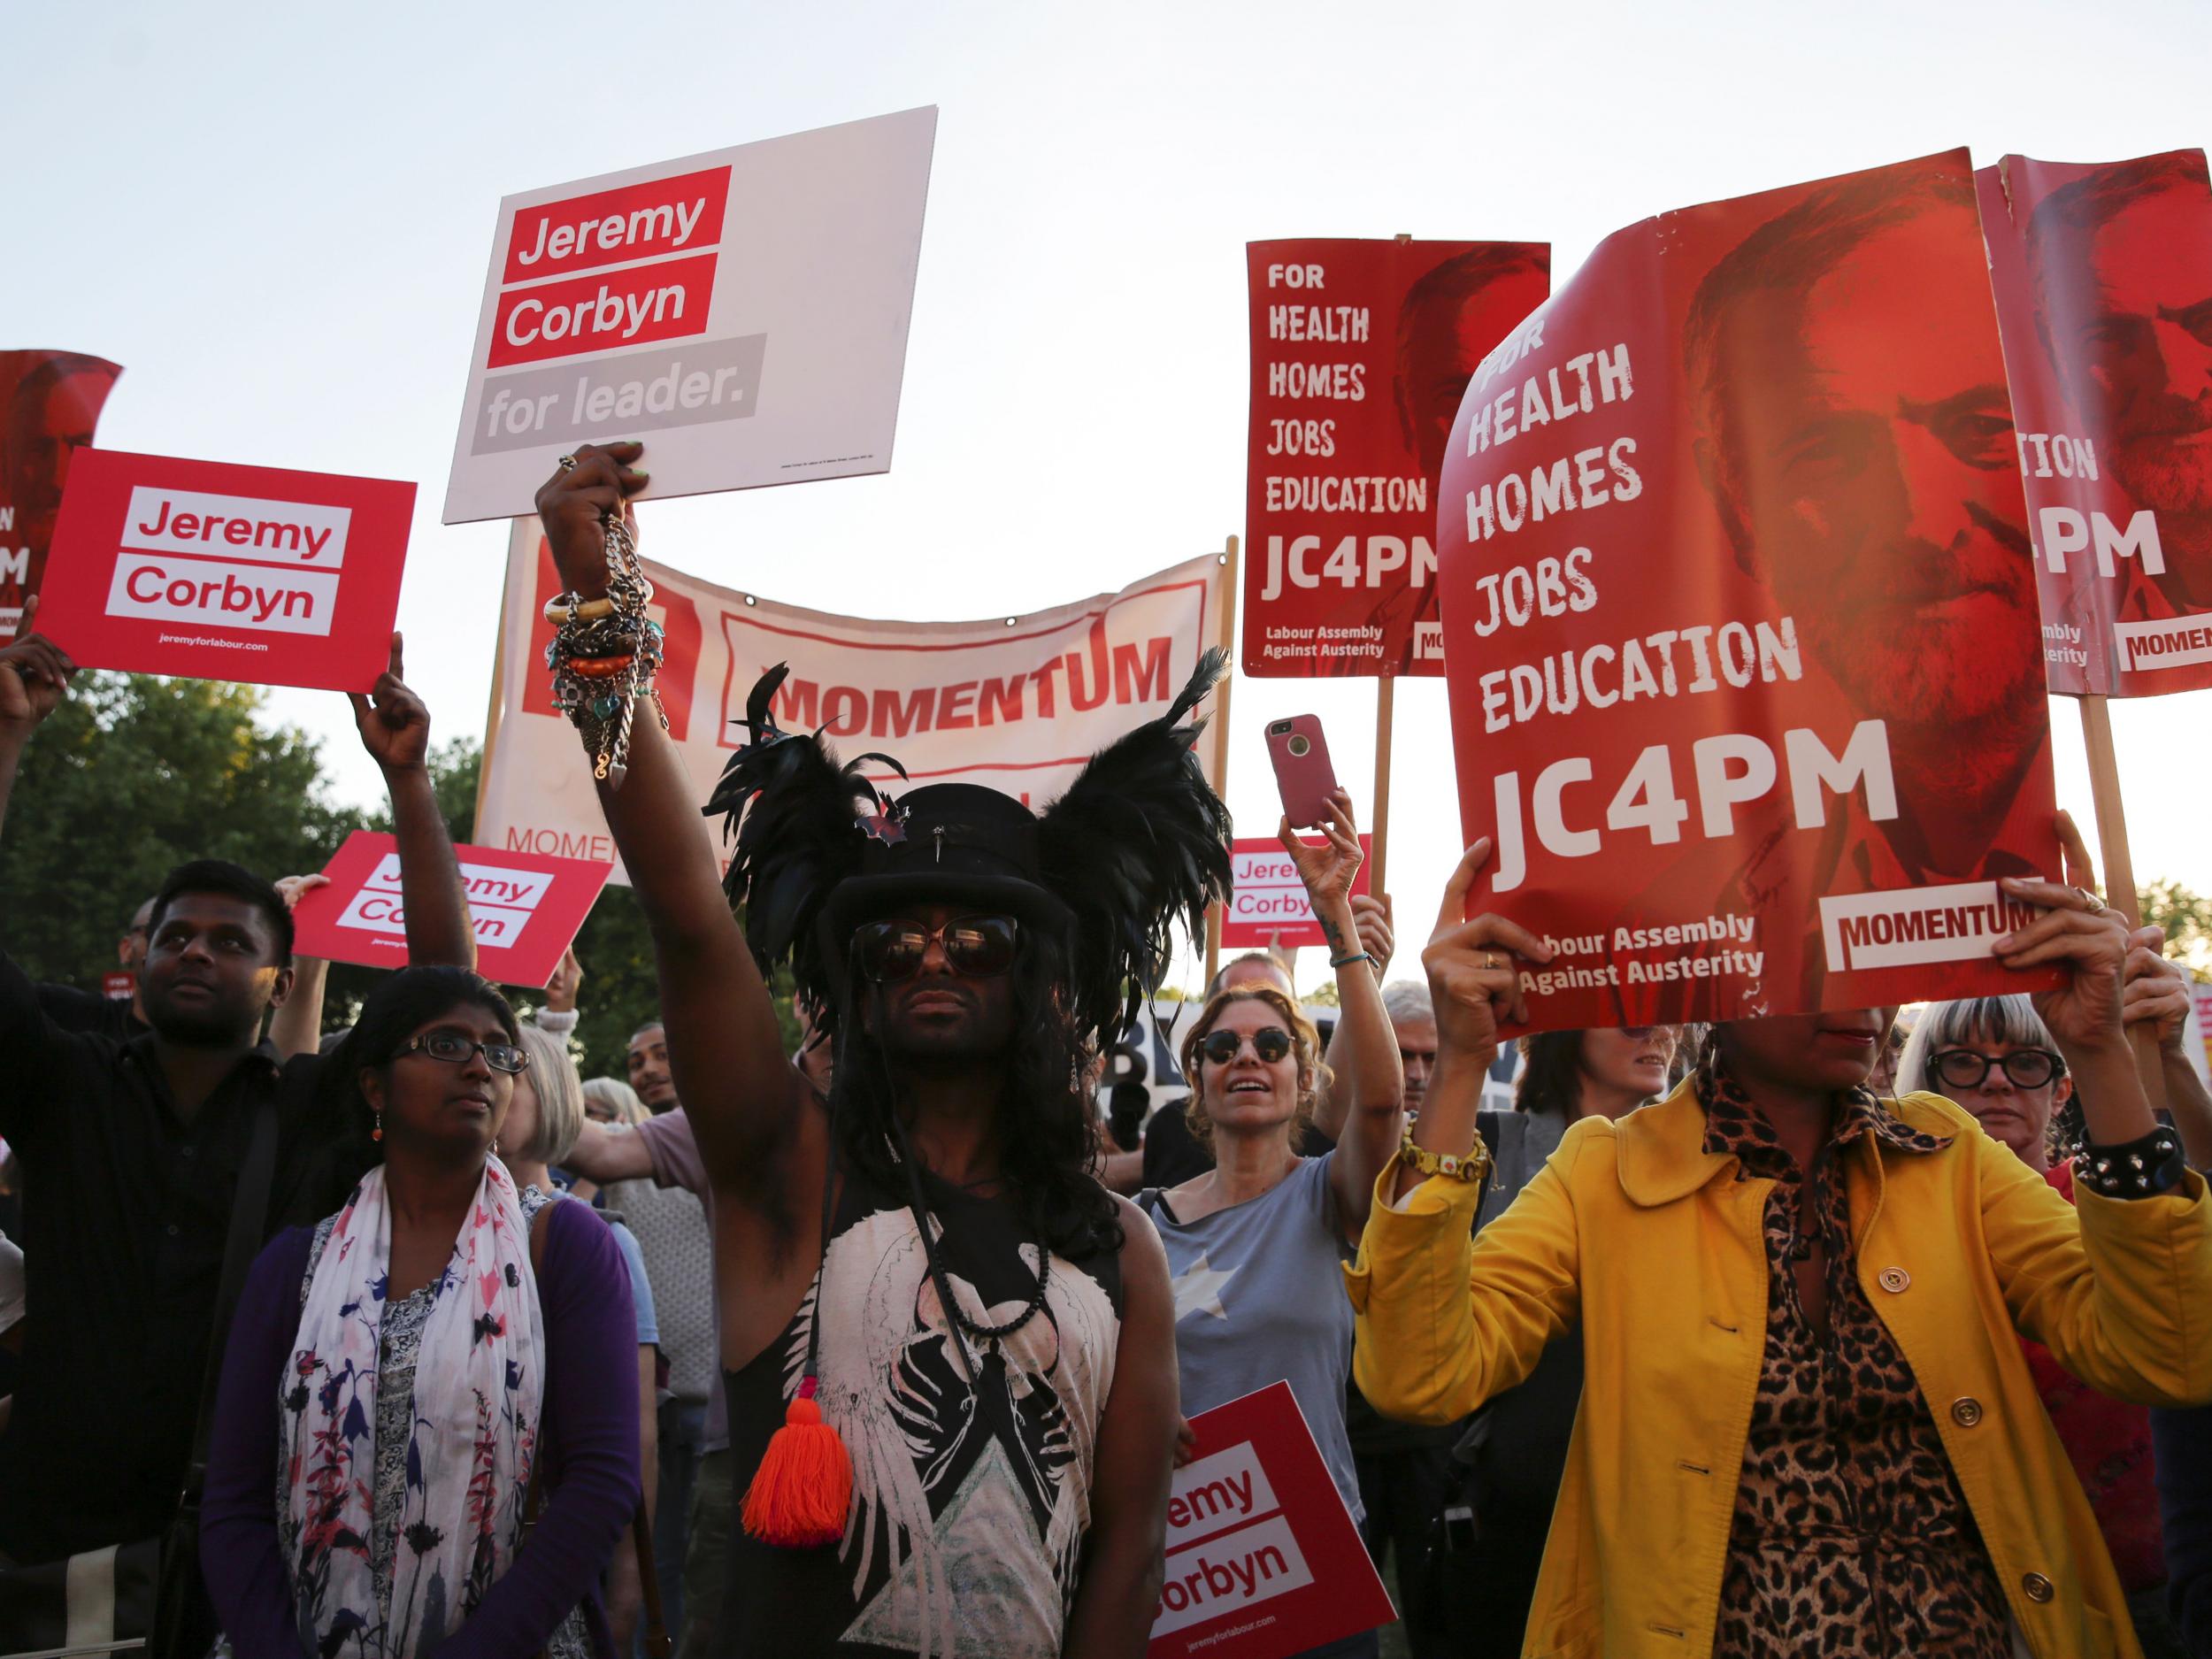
[0,675,352,989]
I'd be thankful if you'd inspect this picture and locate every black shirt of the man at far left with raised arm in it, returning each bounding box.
[0,954,336,1562]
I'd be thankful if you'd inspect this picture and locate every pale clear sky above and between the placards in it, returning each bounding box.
[0,0,2212,978]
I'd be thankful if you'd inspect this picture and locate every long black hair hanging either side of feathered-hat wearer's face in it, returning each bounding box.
[830,927,1122,1261]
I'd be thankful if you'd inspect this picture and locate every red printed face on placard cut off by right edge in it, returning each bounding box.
[2029,150,2212,618]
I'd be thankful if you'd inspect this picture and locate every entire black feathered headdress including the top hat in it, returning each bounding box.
[706,649,1230,1040]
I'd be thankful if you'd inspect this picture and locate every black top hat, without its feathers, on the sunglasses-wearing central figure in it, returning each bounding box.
[814,783,1075,978]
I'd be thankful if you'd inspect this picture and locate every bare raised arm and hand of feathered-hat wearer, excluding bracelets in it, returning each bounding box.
[538,445,810,1202]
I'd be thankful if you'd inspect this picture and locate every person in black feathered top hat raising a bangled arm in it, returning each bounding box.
[538,445,1230,1659]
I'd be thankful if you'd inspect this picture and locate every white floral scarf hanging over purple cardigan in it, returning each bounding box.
[279,1157,544,1659]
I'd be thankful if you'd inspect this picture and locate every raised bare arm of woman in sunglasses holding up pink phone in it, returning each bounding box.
[1277,790,1405,1241]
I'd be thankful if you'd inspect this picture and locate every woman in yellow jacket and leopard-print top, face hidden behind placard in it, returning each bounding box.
[1348,843,2212,1659]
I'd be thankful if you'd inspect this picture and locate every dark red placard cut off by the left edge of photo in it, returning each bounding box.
[0,352,122,640]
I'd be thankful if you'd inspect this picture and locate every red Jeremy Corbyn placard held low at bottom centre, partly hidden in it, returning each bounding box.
[1146,1383,1396,1659]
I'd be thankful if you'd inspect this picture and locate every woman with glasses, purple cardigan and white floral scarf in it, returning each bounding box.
[199,969,640,1659]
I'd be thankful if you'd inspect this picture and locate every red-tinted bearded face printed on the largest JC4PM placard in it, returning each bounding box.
[1668,162,2048,1013]
